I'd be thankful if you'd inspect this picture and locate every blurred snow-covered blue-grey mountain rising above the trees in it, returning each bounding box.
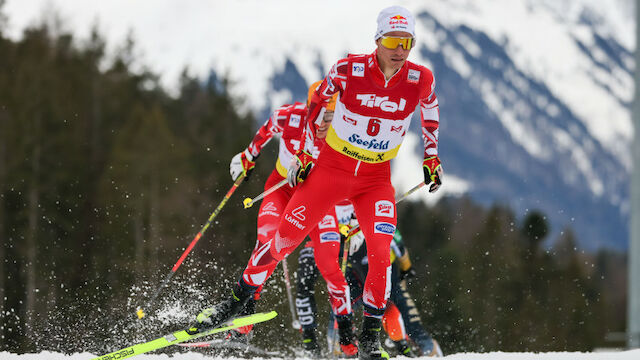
[5,0,634,249]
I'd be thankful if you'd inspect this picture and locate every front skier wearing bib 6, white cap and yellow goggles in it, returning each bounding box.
[198,6,442,359]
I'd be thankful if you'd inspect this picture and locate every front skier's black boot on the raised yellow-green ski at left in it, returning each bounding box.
[193,282,255,331]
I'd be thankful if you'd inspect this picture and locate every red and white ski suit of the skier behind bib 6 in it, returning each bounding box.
[242,102,351,315]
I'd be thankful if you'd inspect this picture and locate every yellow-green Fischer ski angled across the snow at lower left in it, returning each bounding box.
[92,311,278,360]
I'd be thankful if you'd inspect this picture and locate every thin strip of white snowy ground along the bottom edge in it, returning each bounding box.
[0,349,640,360]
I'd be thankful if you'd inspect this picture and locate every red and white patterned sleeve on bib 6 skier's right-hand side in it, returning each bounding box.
[420,75,440,158]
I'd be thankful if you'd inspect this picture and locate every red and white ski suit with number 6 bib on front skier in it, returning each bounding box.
[272,52,439,317]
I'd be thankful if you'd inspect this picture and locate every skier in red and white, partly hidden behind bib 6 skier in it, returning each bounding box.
[214,81,358,355]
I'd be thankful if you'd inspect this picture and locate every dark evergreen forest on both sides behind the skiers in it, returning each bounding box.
[0,11,625,353]
